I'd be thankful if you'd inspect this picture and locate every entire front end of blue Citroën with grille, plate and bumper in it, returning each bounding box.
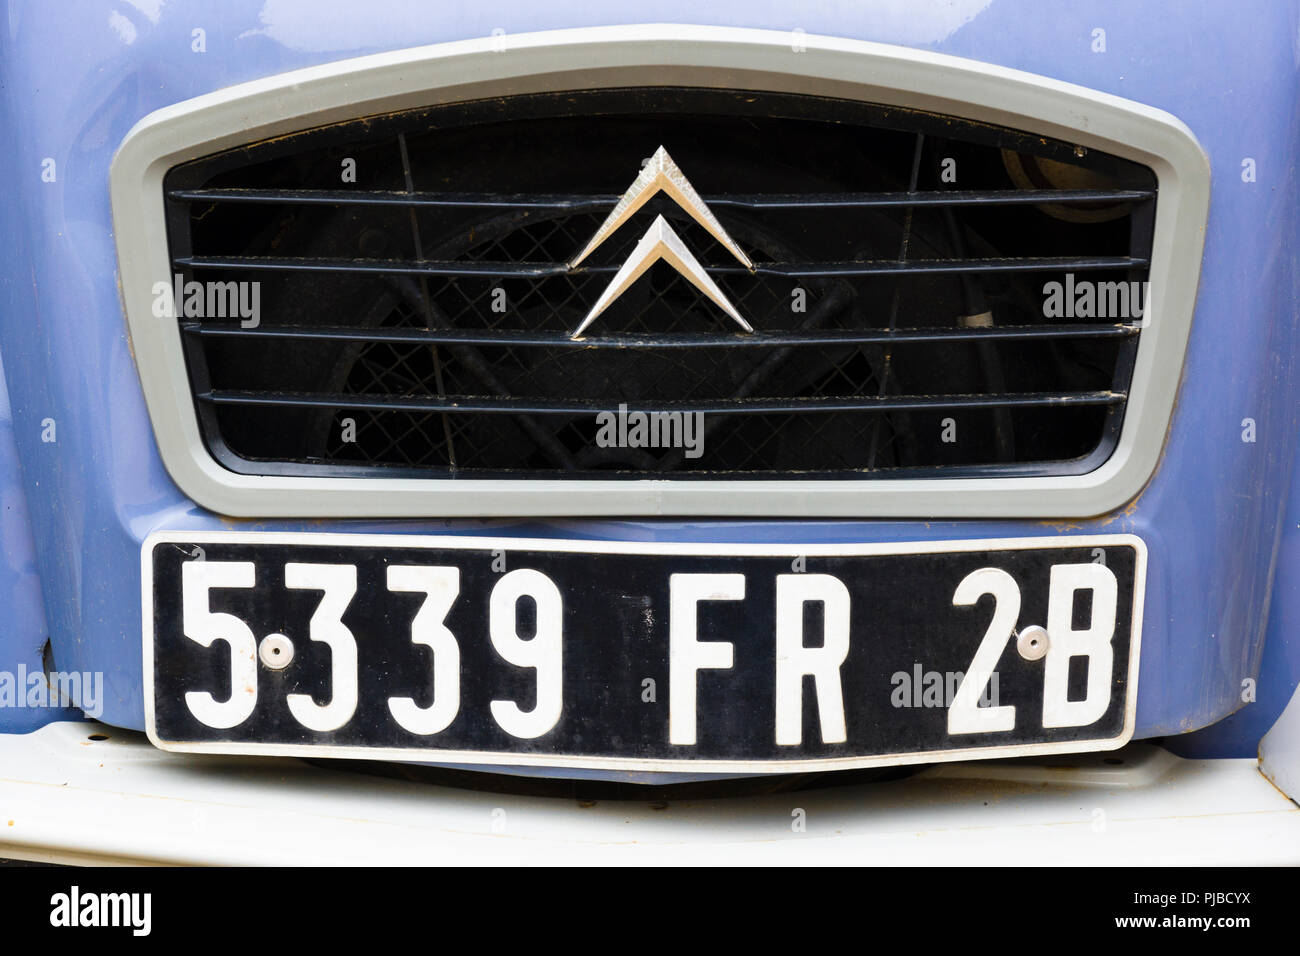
[0,0,1300,862]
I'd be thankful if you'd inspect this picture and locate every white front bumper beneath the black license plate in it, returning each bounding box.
[0,723,1300,865]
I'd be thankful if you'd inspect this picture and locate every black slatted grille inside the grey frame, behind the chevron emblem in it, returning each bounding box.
[165,90,1156,477]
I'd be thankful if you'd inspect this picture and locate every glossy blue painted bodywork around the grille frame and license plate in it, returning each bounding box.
[0,0,1300,770]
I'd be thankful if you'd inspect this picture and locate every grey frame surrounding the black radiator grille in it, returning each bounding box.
[111,25,1209,518]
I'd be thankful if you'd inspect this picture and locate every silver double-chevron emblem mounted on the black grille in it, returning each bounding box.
[569,146,754,338]
